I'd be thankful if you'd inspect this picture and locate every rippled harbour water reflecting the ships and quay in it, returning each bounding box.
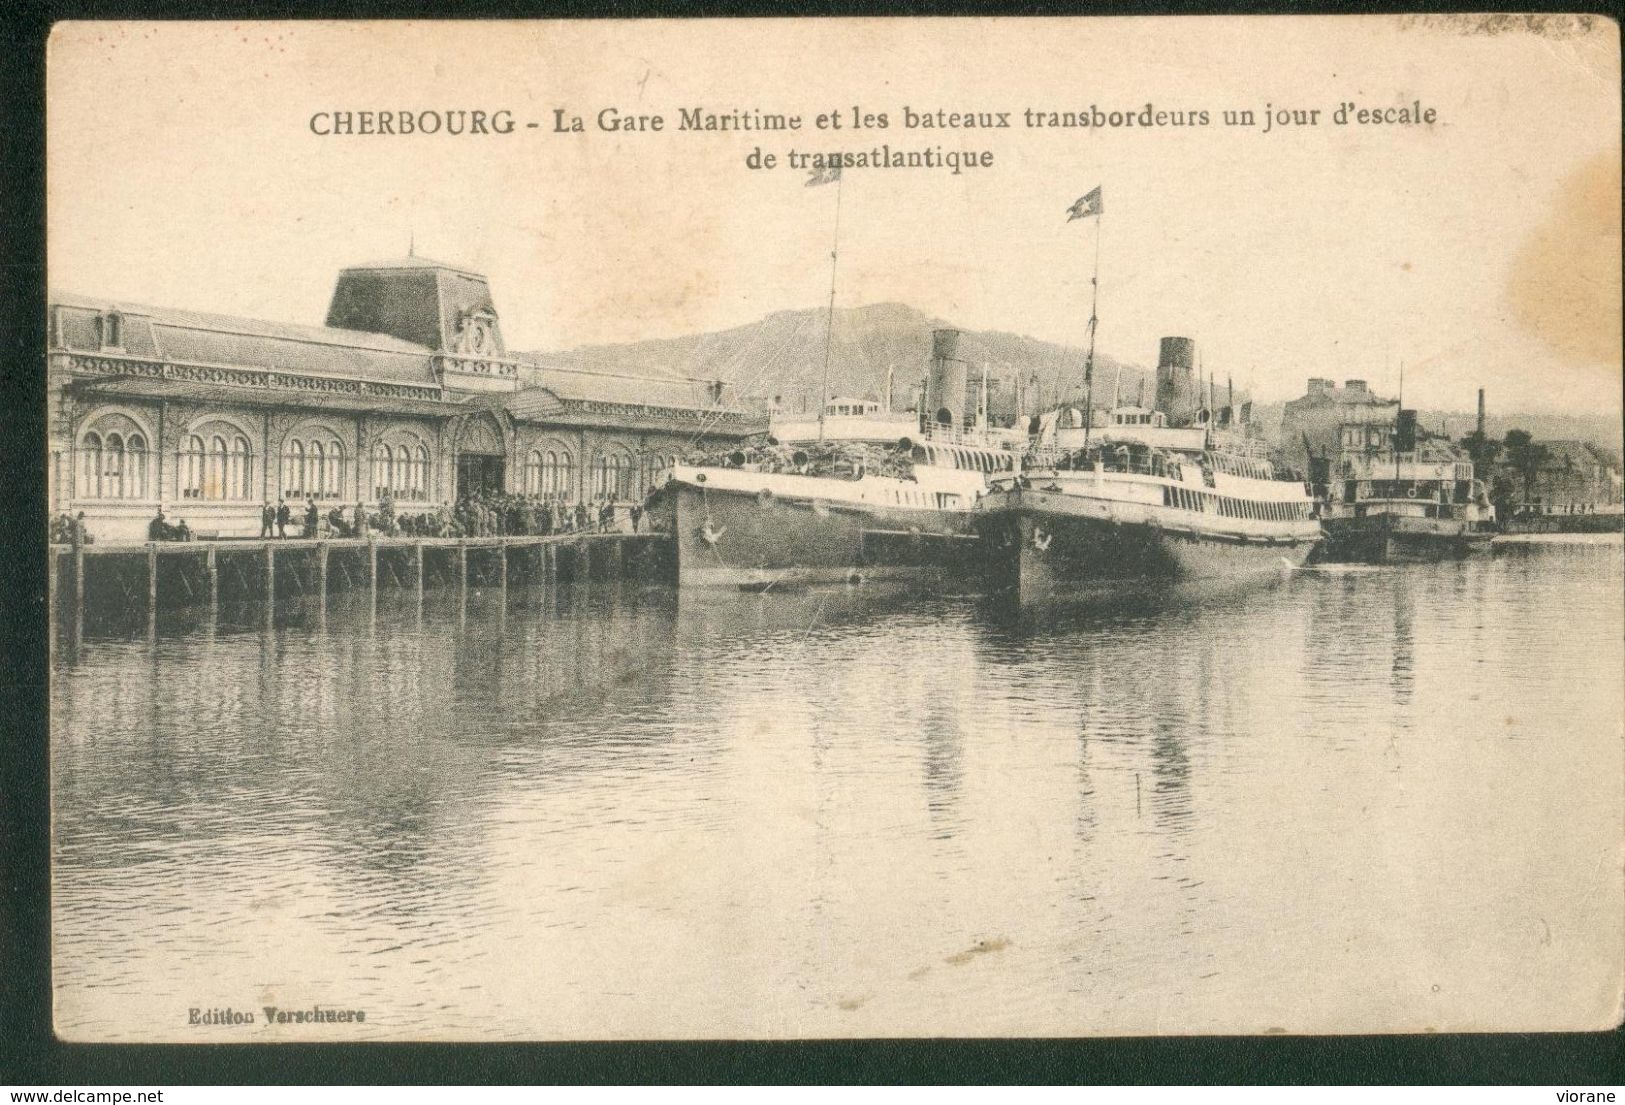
[52,541,1625,1042]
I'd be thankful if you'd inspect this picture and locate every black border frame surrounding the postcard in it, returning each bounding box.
[0,0,1625,1089]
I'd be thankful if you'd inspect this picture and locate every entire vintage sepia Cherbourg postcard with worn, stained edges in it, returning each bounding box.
[39,15,1625,1043]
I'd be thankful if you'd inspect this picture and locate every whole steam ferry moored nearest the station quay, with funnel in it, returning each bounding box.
[650,330,1025,590]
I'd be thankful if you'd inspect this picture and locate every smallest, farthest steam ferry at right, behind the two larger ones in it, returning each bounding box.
[1305,410,1495,564]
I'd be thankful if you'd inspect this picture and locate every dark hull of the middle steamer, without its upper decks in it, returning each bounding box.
[980,496,1318,605]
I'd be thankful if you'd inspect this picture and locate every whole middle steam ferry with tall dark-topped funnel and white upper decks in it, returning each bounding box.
[978,338,1323,605]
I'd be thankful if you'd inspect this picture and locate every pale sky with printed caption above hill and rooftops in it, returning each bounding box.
[47,16,1622,414]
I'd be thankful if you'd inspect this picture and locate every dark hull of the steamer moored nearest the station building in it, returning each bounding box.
[653,479,977,590]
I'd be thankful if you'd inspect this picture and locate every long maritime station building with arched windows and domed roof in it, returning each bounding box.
[46,257,767,541]
